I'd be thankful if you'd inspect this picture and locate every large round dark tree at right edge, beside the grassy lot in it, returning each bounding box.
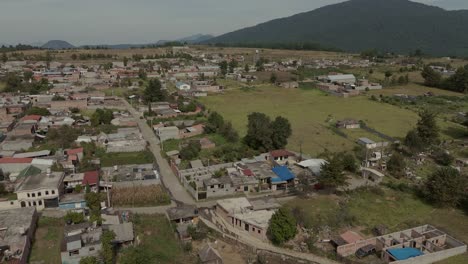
[423,167,467,206]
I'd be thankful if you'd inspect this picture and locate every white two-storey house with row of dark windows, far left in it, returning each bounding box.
[15,172,64,211]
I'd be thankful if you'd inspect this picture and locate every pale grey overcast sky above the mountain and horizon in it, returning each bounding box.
[0,0,468,45]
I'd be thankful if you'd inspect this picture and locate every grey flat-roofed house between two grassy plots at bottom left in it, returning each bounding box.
[60,223,102,264]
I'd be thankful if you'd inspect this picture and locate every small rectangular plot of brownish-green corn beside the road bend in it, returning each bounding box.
[111,185,170,207]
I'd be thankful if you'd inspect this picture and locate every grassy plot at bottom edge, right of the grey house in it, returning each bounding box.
[121,215,196,264]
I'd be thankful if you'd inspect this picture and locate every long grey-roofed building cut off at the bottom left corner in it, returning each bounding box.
[0,207,39,264]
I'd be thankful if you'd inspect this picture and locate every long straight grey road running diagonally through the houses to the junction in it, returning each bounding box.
[122,99,195,204]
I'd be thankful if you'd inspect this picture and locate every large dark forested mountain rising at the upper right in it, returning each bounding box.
[208,0,468,56]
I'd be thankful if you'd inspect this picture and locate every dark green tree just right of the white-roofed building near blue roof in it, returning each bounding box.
[319,155,347,189]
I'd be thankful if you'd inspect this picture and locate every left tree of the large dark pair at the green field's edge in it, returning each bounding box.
[244,112,273,151]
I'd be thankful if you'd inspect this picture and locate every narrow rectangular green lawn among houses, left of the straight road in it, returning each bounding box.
[100,150,154,167]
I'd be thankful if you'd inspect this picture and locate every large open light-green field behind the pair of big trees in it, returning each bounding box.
[200,85,417,154]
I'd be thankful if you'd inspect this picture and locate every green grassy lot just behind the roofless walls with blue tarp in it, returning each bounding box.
[286,188,468,264]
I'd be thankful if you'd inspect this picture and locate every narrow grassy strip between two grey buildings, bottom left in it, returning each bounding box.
[28,217,64,263]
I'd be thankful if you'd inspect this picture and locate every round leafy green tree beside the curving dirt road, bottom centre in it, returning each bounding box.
[267,207,297,245]
